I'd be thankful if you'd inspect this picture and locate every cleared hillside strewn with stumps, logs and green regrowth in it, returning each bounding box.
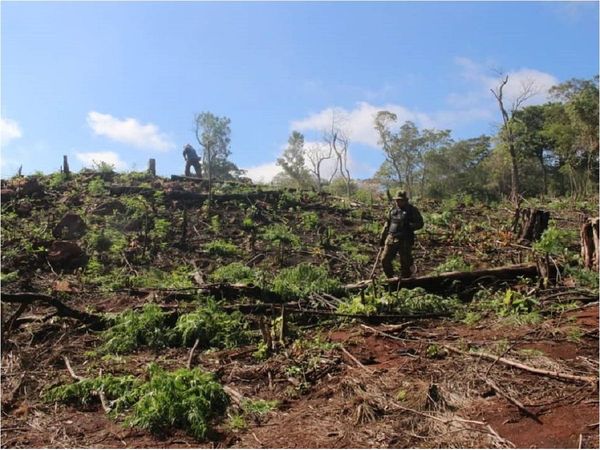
[2,170,598,448]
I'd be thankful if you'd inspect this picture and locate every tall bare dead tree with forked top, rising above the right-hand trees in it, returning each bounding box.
[490,75,537,203]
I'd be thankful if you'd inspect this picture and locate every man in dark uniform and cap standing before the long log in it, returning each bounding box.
[379,191,423,278]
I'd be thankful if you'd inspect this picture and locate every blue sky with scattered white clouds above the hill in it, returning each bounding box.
[0,1,599,181]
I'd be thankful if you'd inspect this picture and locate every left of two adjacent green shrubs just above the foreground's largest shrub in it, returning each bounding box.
[99,303,175,354]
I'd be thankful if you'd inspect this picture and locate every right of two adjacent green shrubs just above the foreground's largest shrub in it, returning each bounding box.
[175,298,250,348]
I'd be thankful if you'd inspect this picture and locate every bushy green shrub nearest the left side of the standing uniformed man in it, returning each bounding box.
[272,263,341,300]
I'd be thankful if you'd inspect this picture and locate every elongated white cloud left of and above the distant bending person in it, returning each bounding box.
[87,111,175,151]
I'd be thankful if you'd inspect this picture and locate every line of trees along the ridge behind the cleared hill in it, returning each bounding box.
[194,76,599,201]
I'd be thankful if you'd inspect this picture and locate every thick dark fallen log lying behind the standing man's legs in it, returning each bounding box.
[344,264,555,292]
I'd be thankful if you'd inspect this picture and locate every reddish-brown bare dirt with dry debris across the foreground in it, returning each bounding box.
[2,297,599,448]
